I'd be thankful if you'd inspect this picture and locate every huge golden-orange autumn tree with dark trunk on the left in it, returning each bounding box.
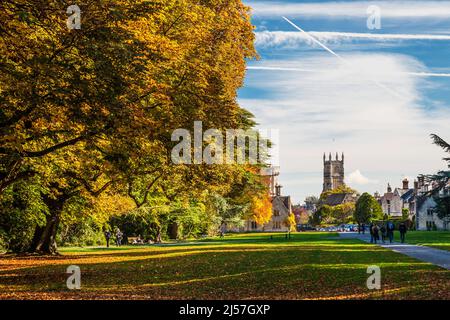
[0,0,255,253]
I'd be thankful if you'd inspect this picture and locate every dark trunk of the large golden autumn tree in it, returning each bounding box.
[29,198,65,254]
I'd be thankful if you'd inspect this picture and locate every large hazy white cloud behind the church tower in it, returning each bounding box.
[239,52,450,202]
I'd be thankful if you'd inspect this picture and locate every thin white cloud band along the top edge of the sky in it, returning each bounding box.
[246,1,450,18]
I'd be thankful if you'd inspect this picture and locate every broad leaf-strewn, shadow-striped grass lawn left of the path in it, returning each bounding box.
[0,233,450,299]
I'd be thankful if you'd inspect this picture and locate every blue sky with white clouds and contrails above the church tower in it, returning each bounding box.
[239,0,450,203]
